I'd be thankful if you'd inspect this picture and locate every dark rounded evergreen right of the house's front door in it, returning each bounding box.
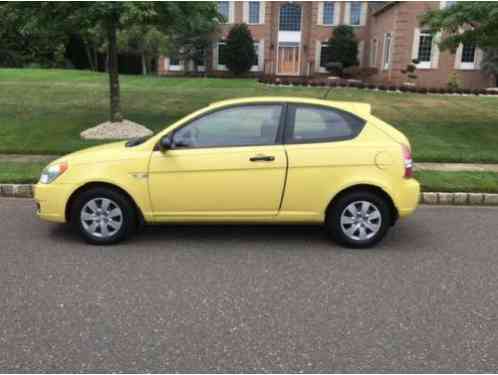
[326,25,358,73]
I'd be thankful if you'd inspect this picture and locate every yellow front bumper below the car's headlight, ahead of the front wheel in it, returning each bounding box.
[34,183,74,223]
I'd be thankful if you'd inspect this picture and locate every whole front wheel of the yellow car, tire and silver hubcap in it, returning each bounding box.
[71,187,137,245]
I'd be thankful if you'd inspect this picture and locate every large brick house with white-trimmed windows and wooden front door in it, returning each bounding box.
[159,1,495,88]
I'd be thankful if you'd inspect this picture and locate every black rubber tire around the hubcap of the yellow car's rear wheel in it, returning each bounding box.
[325,191,392,249]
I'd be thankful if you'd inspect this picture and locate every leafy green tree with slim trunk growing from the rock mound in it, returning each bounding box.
[5,1,219,122]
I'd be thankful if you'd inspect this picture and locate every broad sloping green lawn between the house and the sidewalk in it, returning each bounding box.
[0,69,498,162]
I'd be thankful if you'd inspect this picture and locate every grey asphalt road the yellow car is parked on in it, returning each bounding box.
[0,199,498,372]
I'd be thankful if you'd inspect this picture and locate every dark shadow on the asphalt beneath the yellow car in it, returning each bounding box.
[50,220,437,251]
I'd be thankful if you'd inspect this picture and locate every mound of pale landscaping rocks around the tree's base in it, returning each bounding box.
[80,120,152,139]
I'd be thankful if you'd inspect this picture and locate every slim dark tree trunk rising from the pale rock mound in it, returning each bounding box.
[107,21,123,122]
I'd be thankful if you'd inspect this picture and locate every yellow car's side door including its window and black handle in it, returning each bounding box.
[149,103,287,221]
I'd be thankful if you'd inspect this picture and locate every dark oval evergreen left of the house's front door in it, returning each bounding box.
[224,23,257,75]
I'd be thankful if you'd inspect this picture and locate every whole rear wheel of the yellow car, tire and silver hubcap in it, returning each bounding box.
[325,191,392,249]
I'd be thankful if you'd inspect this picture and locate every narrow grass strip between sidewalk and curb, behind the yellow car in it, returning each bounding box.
[0,162,498,193]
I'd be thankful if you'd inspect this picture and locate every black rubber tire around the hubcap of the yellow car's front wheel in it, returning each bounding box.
[71,188,137,245]
